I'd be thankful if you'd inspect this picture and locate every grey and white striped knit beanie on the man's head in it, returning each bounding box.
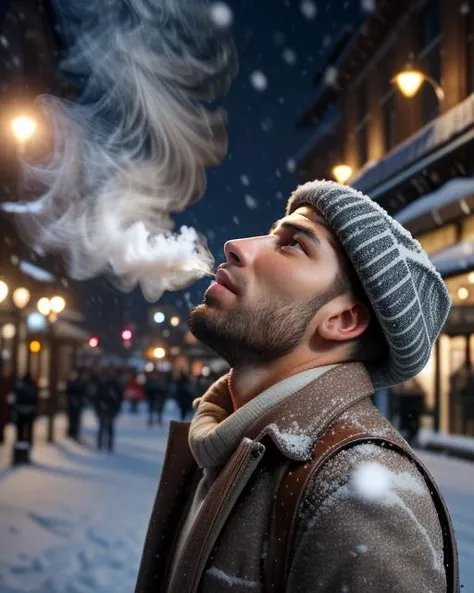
[286,181,451,388]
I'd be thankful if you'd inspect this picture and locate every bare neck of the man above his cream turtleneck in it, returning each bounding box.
[229,356,342,411]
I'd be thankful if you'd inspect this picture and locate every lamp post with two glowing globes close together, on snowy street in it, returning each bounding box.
[37,296,66,443]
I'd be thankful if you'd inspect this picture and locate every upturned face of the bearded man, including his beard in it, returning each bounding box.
[189,206,343,366]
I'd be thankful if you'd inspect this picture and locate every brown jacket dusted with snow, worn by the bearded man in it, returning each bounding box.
[135,363,446,593]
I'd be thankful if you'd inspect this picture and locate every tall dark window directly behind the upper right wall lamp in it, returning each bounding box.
[418,0,441,124]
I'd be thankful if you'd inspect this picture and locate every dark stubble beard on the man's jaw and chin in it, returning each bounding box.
[189,290,322,367]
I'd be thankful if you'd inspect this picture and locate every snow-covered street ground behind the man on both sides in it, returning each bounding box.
[0,402,474,593]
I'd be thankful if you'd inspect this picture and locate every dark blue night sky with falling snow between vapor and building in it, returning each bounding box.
[74,0,364,344]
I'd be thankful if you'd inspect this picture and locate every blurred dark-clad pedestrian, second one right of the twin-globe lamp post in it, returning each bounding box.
[93,369,123,452]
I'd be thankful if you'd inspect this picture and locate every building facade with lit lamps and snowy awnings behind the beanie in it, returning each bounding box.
[298,0,474,435]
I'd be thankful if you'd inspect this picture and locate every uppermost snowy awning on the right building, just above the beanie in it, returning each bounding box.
[351,93,474,199]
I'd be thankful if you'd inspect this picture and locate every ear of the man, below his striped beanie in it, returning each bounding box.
[317,301,370,342]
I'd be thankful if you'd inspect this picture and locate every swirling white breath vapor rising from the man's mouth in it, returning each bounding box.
[3,0,237,301]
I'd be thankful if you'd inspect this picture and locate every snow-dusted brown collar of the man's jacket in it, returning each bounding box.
[245,363,374,461]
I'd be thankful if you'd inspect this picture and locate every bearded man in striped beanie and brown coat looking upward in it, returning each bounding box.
[136,181,456,593]
